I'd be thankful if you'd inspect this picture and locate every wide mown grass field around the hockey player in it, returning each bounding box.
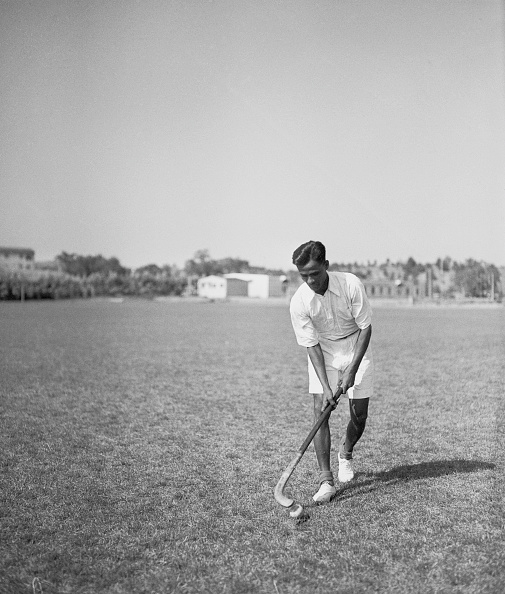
[0,301,505,594]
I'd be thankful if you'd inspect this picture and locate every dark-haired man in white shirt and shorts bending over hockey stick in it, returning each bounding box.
[290,241,373,503]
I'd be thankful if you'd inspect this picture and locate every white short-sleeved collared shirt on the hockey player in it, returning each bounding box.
[289,272,372,347]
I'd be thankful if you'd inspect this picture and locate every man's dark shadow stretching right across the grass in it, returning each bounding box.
[311,460,496,507]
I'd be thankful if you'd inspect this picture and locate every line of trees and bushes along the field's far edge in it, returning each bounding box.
[0,250,503,300]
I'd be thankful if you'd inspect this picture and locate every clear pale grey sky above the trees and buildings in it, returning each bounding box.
[0,0,505,269]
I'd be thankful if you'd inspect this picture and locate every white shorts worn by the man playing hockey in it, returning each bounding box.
[308,332,374,400]
